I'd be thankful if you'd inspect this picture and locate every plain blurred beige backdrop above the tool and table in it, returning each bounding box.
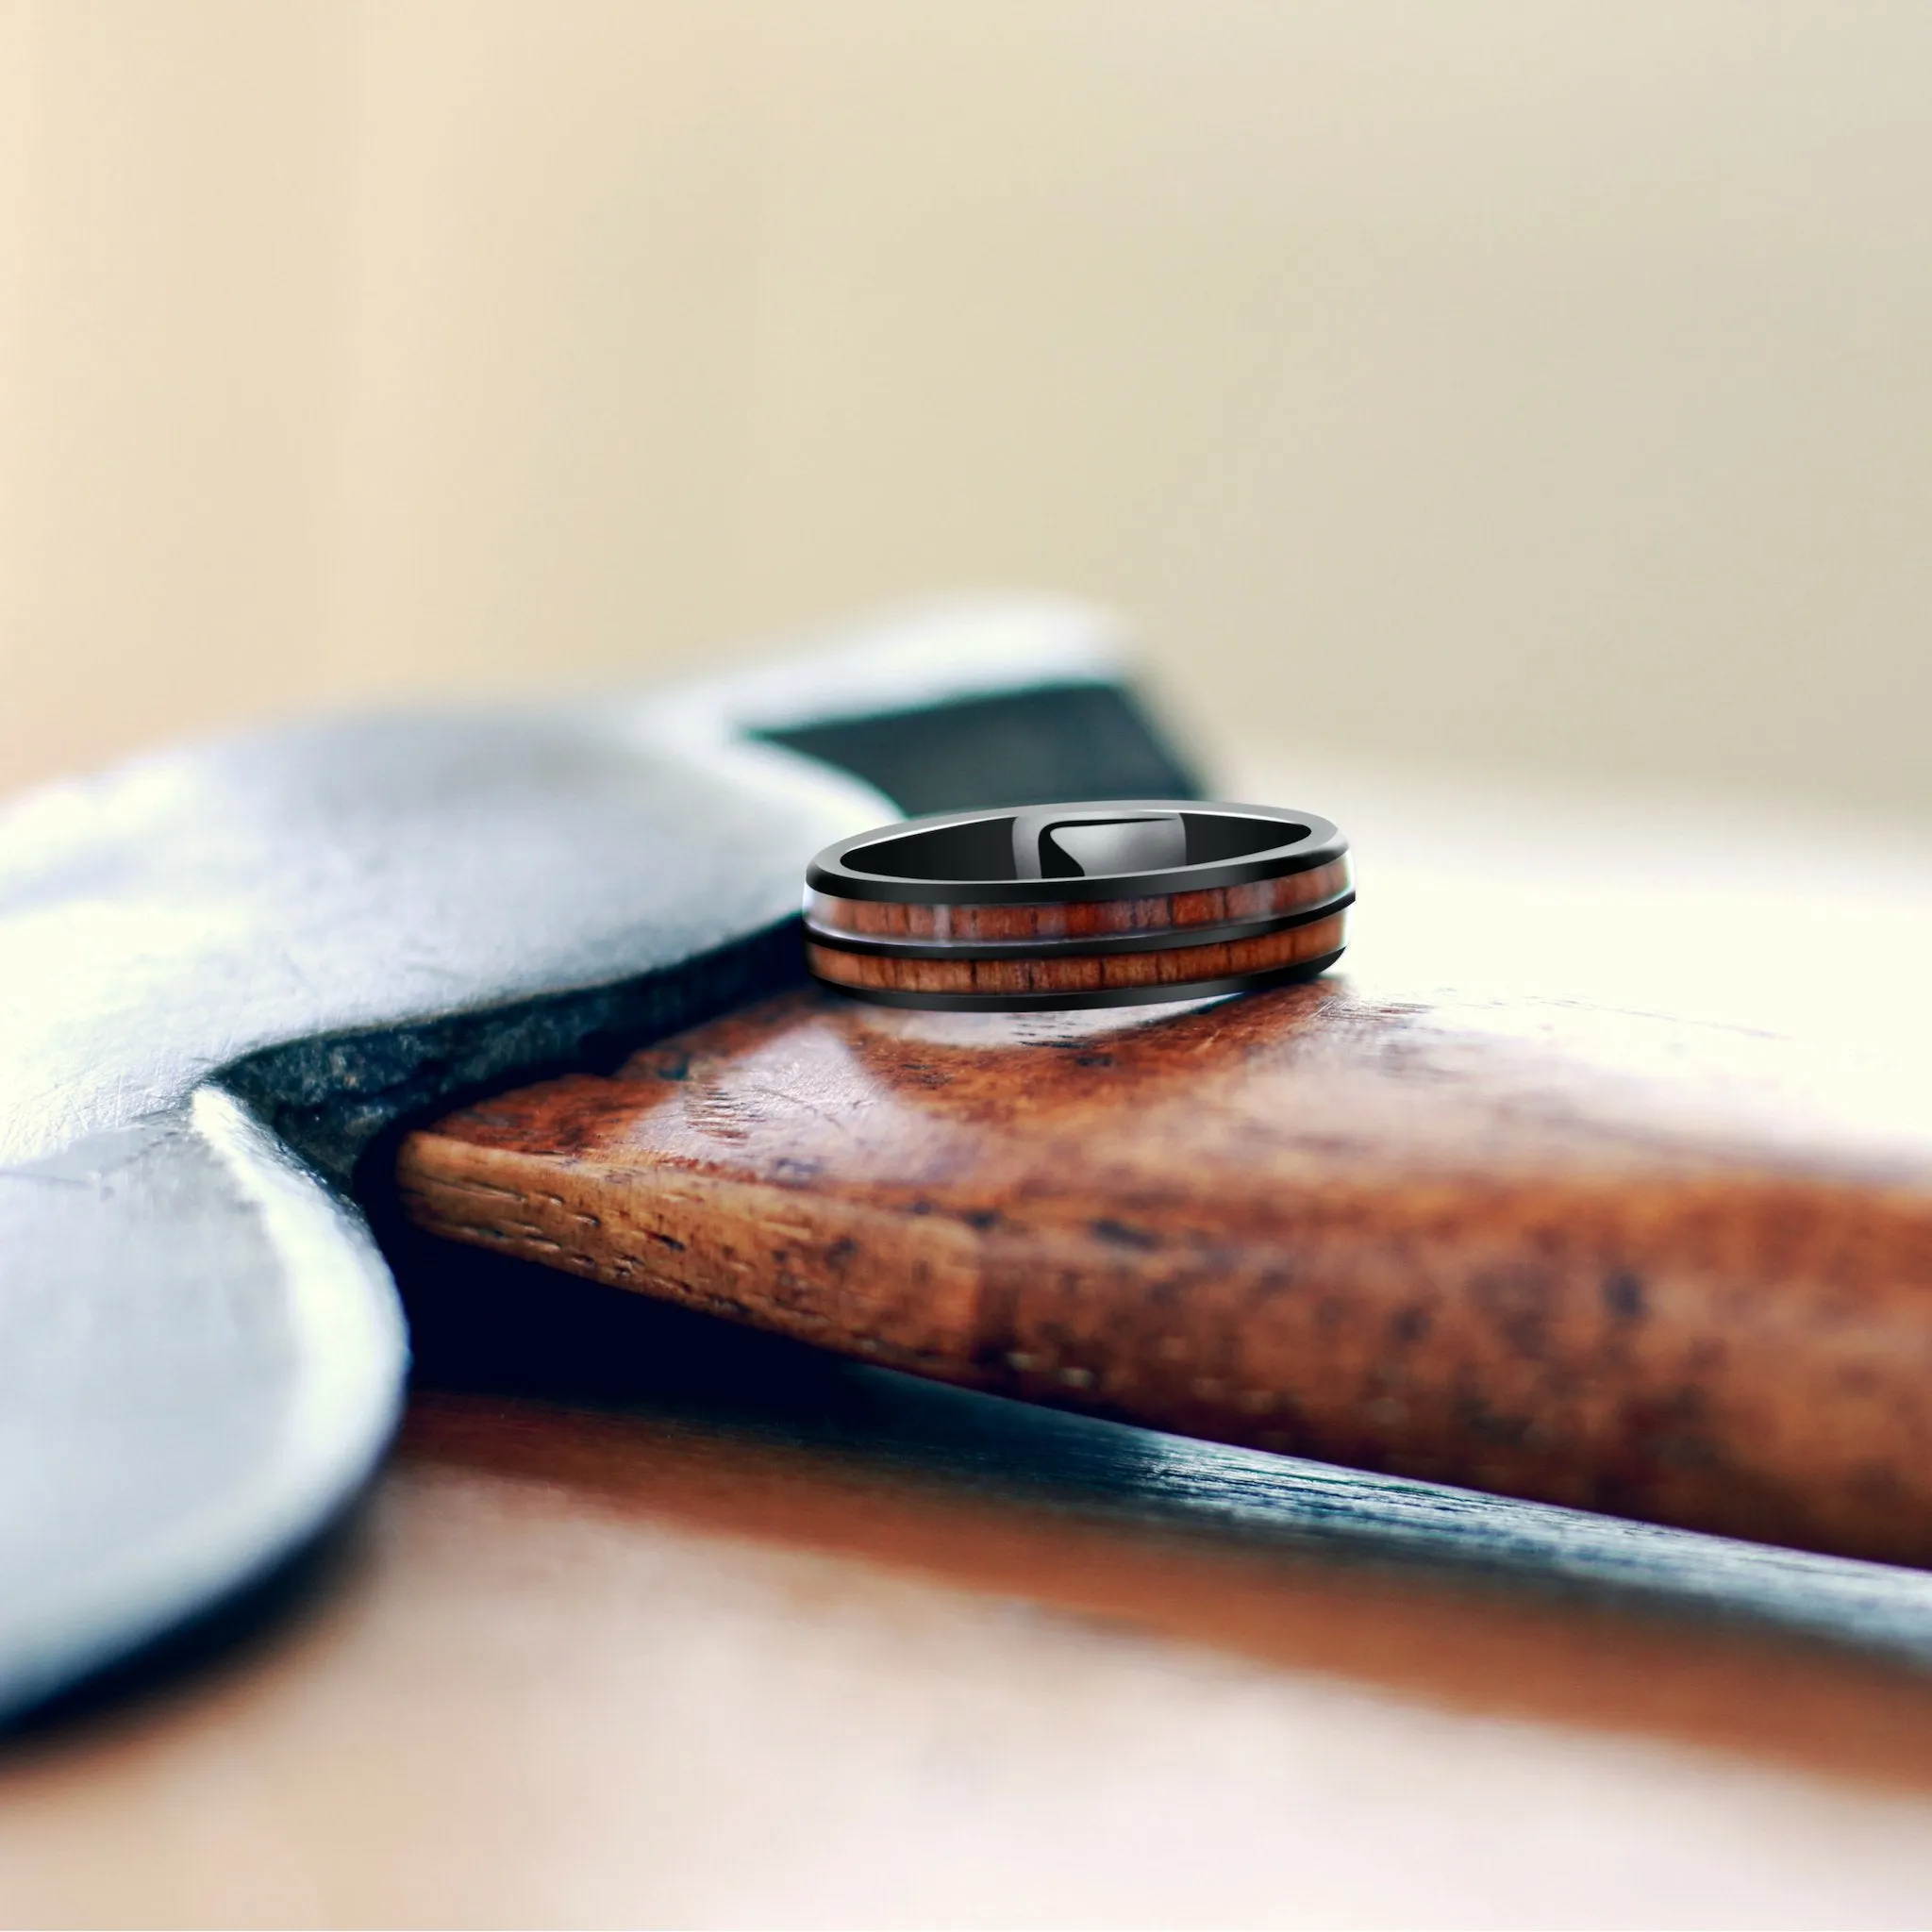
[0,0,1932,823]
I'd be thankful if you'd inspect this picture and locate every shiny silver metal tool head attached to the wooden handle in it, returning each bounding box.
[0,605,1189,1716]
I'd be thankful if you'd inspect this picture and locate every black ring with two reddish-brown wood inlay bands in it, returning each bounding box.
[806,798,1355,1012]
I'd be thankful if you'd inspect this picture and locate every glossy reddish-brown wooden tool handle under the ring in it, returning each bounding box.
[400,979,1932,1563]
